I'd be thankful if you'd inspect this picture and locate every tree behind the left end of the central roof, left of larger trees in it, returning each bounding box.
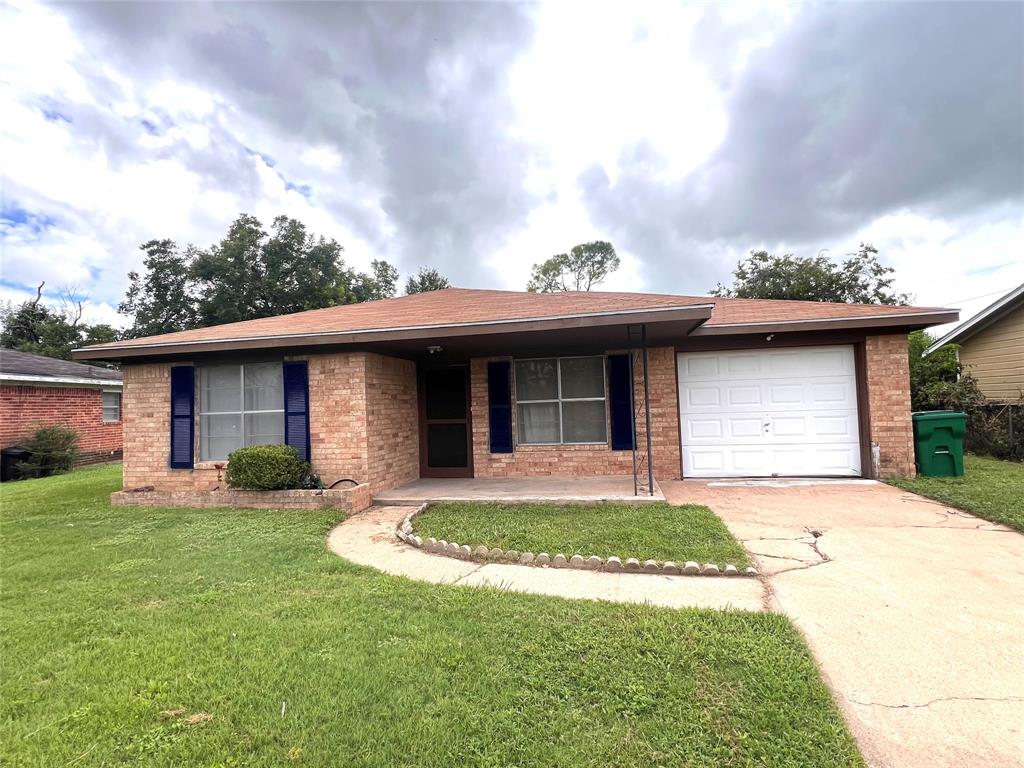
[118,240,196,339]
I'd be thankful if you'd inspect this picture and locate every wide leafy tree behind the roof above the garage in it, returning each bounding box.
[712,243,909,304]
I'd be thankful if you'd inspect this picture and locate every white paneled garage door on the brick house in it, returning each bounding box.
[678,346,860,477]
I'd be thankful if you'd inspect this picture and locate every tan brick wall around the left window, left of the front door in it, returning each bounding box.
[123,352,419,494]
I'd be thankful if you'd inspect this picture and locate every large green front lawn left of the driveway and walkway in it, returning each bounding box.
[0,467,862,768]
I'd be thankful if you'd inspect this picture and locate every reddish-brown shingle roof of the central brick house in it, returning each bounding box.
[74,288,958,358]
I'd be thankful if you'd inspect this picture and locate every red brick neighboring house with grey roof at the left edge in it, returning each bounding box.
[0,349,121,464]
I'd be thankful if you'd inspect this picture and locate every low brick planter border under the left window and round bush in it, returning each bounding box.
[111,483,372,514]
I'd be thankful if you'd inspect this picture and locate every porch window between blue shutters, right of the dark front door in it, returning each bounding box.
[515,357,608,444]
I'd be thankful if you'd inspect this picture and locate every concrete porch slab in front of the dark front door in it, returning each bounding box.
[374,475,665,506]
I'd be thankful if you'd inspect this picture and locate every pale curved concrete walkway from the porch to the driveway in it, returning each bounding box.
[327,506,766,610]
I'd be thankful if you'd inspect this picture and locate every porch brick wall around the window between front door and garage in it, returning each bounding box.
[470,347,680,480]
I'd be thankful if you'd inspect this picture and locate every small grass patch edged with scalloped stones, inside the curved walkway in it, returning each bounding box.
[413,502,750,566]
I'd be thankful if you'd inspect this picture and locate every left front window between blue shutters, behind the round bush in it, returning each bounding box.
[199,362,285,461]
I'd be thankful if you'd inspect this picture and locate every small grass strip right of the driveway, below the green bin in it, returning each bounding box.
[891,454,1024,532]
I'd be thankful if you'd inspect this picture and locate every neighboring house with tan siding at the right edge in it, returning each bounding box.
[925,285,1024,402]
